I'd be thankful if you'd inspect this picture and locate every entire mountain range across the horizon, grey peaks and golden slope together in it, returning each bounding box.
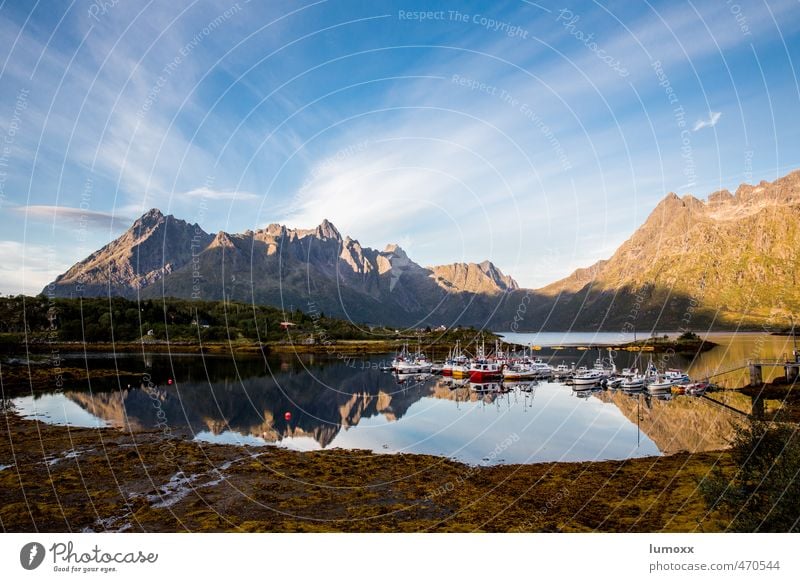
[45,172,800,331]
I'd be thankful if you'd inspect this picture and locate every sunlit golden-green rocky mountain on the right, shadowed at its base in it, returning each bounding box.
[540,172,800,330]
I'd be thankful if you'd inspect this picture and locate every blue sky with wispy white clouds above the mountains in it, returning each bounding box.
[0,0,800,293]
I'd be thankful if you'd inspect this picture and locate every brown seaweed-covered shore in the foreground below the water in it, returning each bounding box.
[0,413,730,532]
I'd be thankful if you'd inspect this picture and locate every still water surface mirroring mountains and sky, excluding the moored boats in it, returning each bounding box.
[13,336,790,464]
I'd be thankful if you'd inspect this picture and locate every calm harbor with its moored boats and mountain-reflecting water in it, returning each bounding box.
[4,338,793,464]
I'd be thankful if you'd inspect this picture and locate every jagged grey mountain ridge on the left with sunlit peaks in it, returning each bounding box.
[45,209,518,325]
